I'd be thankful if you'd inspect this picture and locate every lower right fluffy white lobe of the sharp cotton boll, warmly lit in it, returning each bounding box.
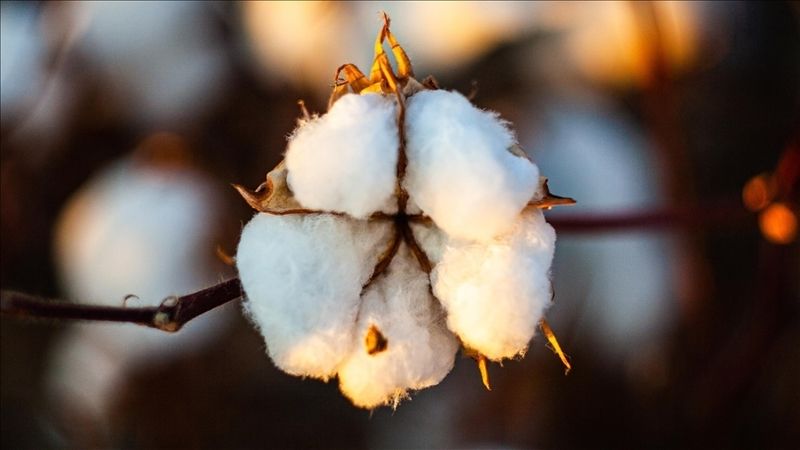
[431,210,556,361]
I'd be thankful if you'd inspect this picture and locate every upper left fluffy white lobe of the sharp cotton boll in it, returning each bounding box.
[286,94,399,218]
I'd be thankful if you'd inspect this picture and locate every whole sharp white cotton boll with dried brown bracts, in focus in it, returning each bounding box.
[235,17,572,409]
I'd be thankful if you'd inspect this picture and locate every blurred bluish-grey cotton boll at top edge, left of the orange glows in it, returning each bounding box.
[67,1,228,126]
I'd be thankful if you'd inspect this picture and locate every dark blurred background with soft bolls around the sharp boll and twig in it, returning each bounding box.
[0,1,800,449]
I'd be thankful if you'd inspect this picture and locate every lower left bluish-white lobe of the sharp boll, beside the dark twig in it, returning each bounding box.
[236,213,390,379]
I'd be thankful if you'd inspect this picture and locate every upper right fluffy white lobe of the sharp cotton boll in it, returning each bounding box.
[404,90,539,241]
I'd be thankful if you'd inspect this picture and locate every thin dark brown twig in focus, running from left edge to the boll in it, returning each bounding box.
[0,278,242,332]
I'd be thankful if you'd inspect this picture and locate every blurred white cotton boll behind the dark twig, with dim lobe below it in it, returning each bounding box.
[48,135,235,442]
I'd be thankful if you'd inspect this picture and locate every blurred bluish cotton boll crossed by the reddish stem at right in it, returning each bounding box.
[527,102,678,370]
